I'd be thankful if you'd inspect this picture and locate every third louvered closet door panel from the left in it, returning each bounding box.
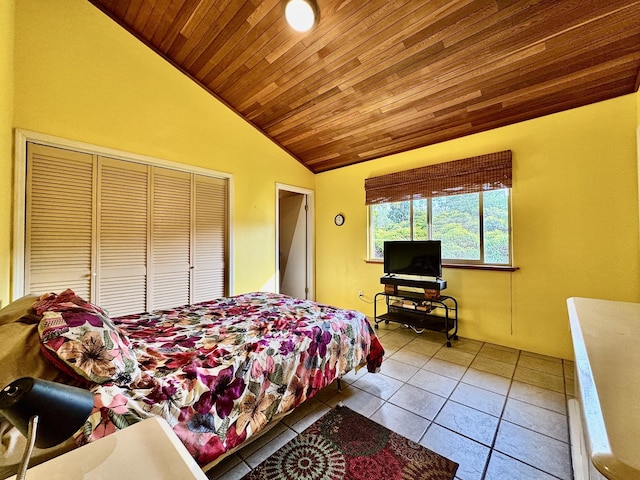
[149,168,191,310]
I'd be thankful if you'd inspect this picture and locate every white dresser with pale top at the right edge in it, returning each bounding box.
[567,298,640,480]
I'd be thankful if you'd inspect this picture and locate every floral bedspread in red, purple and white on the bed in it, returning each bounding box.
[78,293,384,466]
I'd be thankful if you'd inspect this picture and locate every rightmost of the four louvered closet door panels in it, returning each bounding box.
[191,175,227,303]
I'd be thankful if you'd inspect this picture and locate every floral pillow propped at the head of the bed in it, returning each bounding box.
[34,290,140,386]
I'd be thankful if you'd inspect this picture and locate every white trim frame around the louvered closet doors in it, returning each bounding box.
[11,129,234,301]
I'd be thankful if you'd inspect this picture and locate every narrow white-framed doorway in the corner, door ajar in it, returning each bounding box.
[276,184,315,300]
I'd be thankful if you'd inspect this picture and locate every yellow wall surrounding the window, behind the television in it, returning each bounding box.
[316,94,640,358]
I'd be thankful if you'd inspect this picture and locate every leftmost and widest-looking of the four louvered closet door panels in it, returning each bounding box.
[25,143,94,298]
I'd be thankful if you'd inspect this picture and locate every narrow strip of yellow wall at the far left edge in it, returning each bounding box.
[0,0,14,305]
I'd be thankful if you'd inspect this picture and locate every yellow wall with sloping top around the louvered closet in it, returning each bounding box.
[0,0,314,301]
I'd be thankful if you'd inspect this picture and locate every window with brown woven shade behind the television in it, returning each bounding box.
[365,151,511,266]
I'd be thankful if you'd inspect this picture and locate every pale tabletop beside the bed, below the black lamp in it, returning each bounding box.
[12,417,207,480]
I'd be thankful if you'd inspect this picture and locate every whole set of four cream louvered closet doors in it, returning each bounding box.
[25,143,228,316]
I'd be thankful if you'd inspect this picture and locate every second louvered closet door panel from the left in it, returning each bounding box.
[96,157,150,316]
